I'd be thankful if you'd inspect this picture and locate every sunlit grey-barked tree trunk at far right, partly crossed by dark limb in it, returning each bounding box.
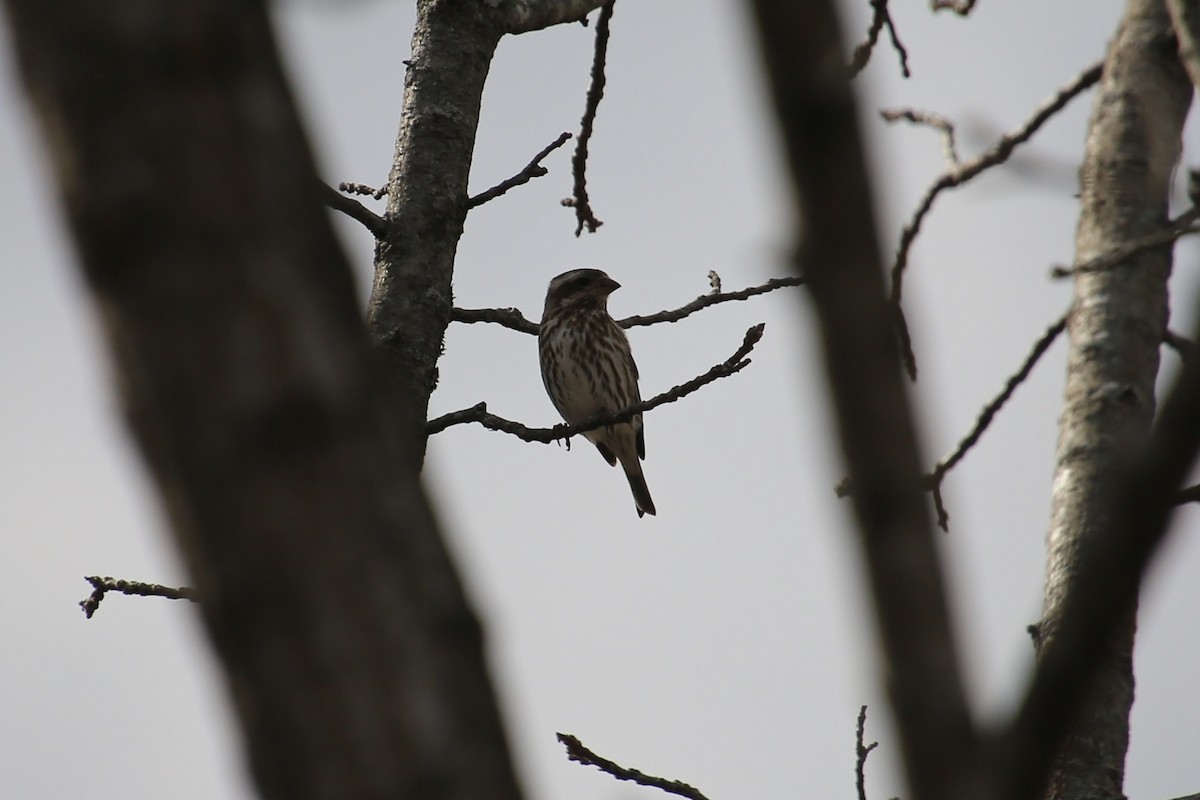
[1037,0,1192,800]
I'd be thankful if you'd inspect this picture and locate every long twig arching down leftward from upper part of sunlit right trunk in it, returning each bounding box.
[890,64,1103,379]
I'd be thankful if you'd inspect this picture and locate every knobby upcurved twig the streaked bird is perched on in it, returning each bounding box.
[425,323,766,444]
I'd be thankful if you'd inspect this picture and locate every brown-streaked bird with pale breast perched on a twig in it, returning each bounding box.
[538,270,655,517]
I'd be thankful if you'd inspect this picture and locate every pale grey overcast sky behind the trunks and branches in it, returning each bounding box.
[0,0,1200,800]
